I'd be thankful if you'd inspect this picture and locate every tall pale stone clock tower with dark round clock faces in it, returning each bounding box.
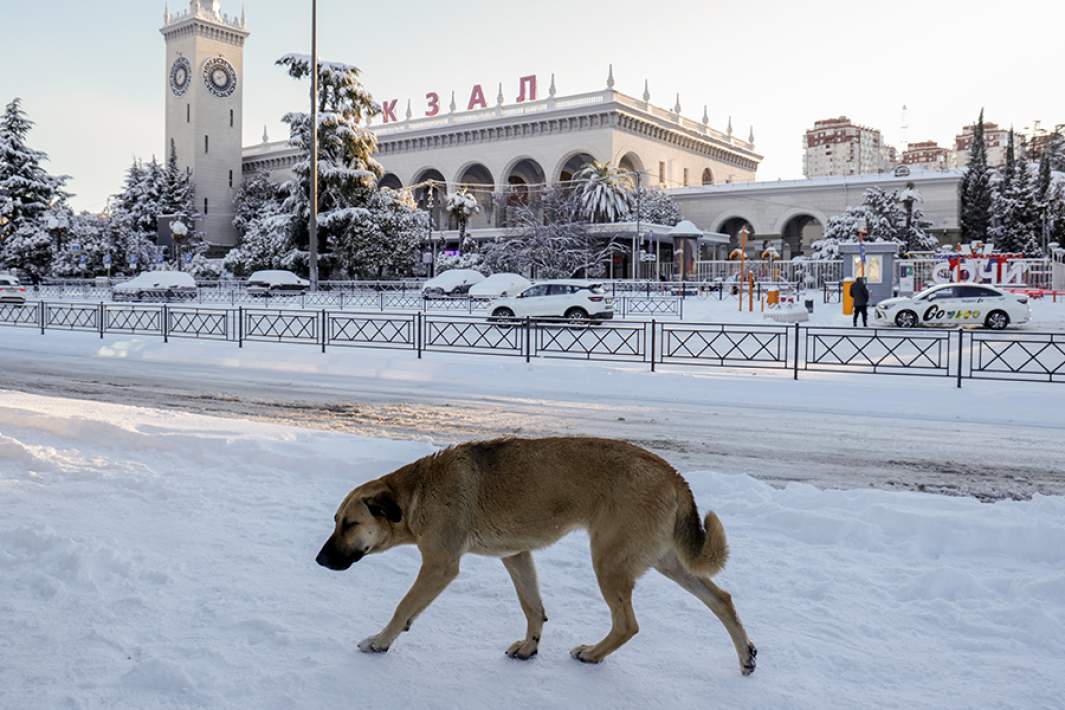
[161,0,248,252]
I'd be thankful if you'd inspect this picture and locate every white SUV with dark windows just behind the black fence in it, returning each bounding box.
[490,280,613,323]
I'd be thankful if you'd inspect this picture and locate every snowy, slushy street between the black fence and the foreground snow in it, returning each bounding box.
[0,331,1065,499]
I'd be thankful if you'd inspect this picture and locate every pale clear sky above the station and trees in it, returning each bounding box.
[0,0,1065,210]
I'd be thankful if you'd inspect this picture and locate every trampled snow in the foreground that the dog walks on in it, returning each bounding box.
[0,393,1065,710]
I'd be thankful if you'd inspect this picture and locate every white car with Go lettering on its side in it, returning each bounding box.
[873,283,1032,330]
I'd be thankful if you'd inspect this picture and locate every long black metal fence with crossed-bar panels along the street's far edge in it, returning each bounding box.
[0,302,1065,386]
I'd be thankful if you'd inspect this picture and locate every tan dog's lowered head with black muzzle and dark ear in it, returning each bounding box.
[315,481,403,572]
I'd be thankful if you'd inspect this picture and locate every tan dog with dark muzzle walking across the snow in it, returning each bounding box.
[316,437,757,675]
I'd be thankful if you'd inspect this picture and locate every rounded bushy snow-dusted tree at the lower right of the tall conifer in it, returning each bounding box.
[322,188,428,279]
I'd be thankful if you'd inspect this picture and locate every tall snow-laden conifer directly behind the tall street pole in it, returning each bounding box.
[277,54,383,263]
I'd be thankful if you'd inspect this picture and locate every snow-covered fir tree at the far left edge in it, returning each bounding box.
[0,99,69,278]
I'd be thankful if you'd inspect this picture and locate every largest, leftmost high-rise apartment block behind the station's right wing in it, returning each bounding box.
[803,116,897,178]
